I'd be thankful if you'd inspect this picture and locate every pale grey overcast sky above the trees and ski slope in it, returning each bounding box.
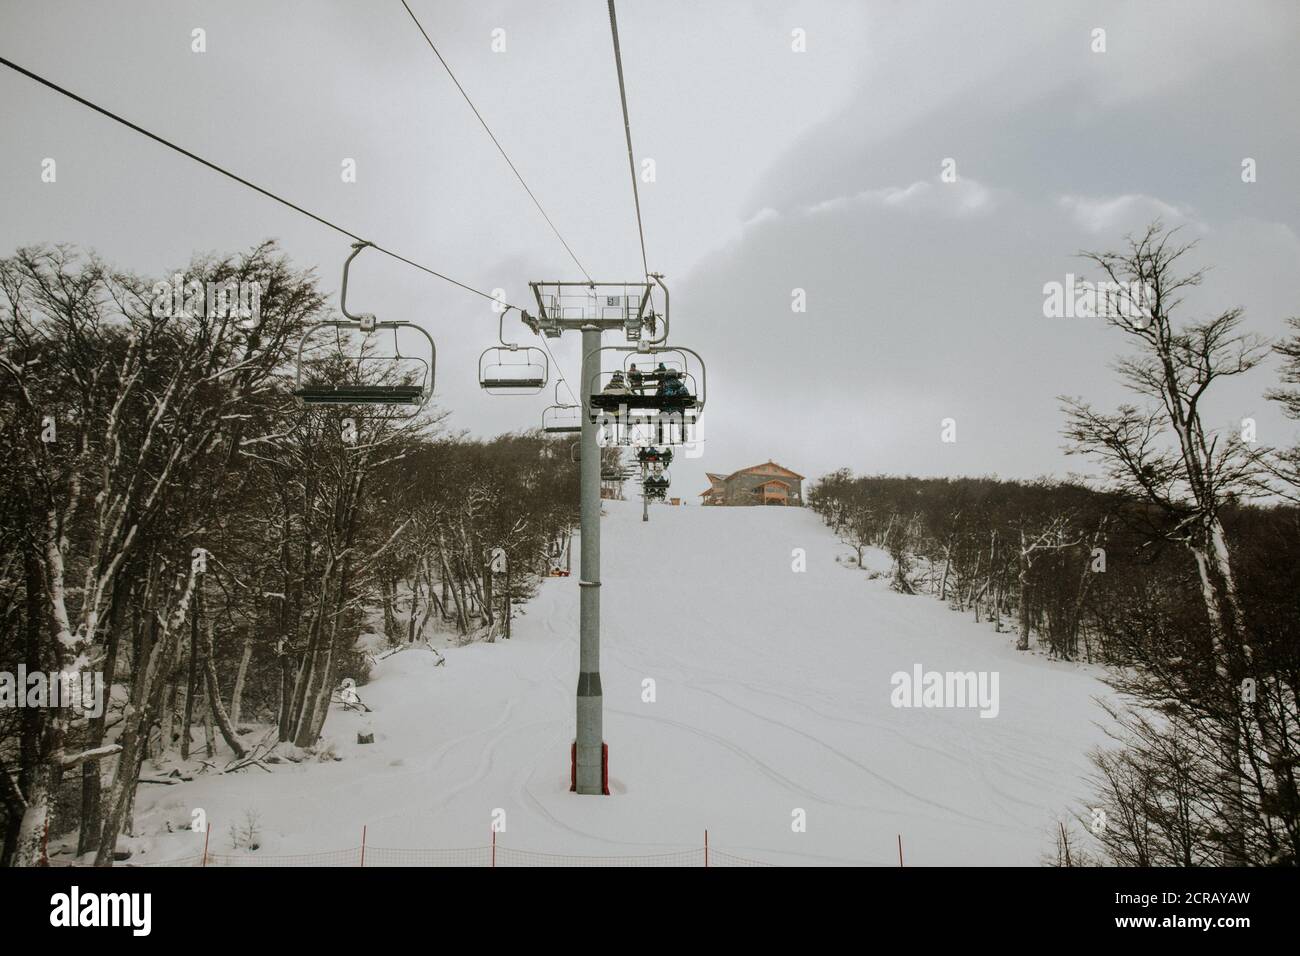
[0,0,1300,501]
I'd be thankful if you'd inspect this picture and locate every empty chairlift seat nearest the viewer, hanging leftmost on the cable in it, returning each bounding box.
[294,241,438,418]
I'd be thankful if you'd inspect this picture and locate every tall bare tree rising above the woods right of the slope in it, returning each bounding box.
[1062,221,1268,862]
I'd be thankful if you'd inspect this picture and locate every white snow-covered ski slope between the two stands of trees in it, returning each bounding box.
[116,502,1106,865]
